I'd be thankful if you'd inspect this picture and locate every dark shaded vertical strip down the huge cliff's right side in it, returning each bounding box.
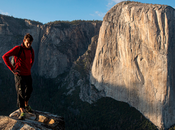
[163,7,175,128]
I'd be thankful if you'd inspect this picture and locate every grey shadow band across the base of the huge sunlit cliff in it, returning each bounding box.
[91,77,158,114]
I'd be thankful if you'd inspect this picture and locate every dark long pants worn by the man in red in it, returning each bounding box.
[15,75,33,108]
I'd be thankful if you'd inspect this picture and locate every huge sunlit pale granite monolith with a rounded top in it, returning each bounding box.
[91,1,175,129]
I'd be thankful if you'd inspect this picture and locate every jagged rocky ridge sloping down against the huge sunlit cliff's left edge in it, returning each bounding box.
[61,35,104,104]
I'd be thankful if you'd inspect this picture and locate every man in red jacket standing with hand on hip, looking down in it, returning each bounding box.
[2,33,34,120]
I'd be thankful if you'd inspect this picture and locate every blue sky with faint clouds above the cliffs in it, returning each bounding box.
[0,0,175,24]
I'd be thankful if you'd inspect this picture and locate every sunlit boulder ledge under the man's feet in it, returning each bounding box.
[0,109,65,130]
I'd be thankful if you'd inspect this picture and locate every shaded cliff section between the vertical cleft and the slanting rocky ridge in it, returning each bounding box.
[38,22,101,78]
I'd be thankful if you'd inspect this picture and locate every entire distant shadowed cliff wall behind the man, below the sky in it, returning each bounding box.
[0,15,101,78]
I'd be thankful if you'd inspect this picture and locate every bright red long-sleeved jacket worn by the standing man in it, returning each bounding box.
[2,43,34,76]
